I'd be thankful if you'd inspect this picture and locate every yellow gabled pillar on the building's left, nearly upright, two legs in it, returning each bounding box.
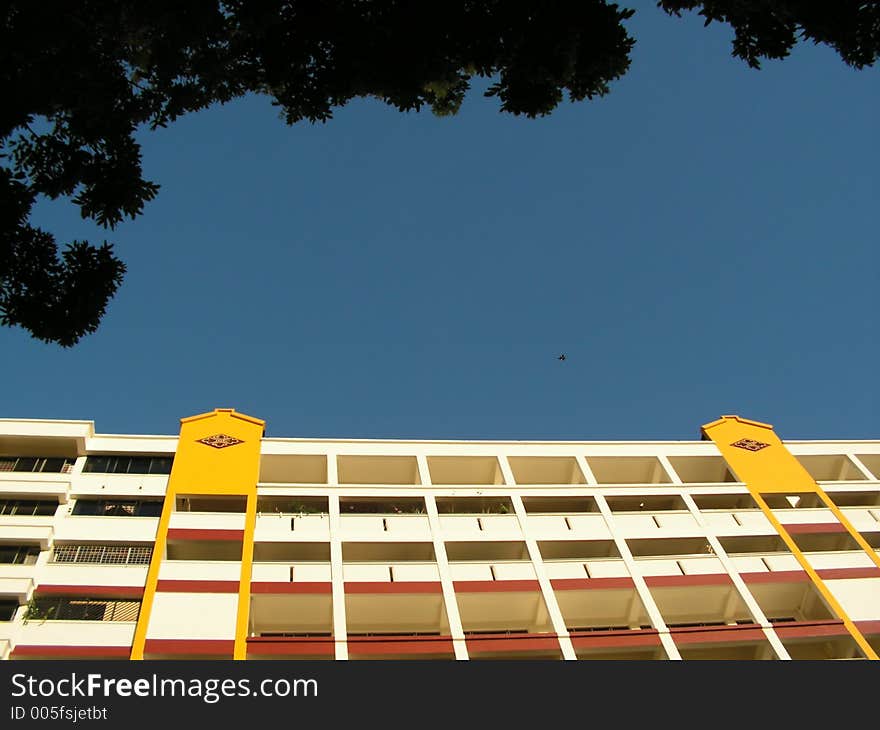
[131,408,265,659]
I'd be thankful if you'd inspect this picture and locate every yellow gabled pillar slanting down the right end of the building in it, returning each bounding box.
[702,416,880,659]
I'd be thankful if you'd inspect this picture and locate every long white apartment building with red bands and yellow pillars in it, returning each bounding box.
[0,409,880,660]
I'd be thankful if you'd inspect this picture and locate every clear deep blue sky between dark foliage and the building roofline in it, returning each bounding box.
[0,2,880,440]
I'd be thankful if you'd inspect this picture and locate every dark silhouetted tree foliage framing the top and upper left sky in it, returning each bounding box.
[0,0,880,346]
